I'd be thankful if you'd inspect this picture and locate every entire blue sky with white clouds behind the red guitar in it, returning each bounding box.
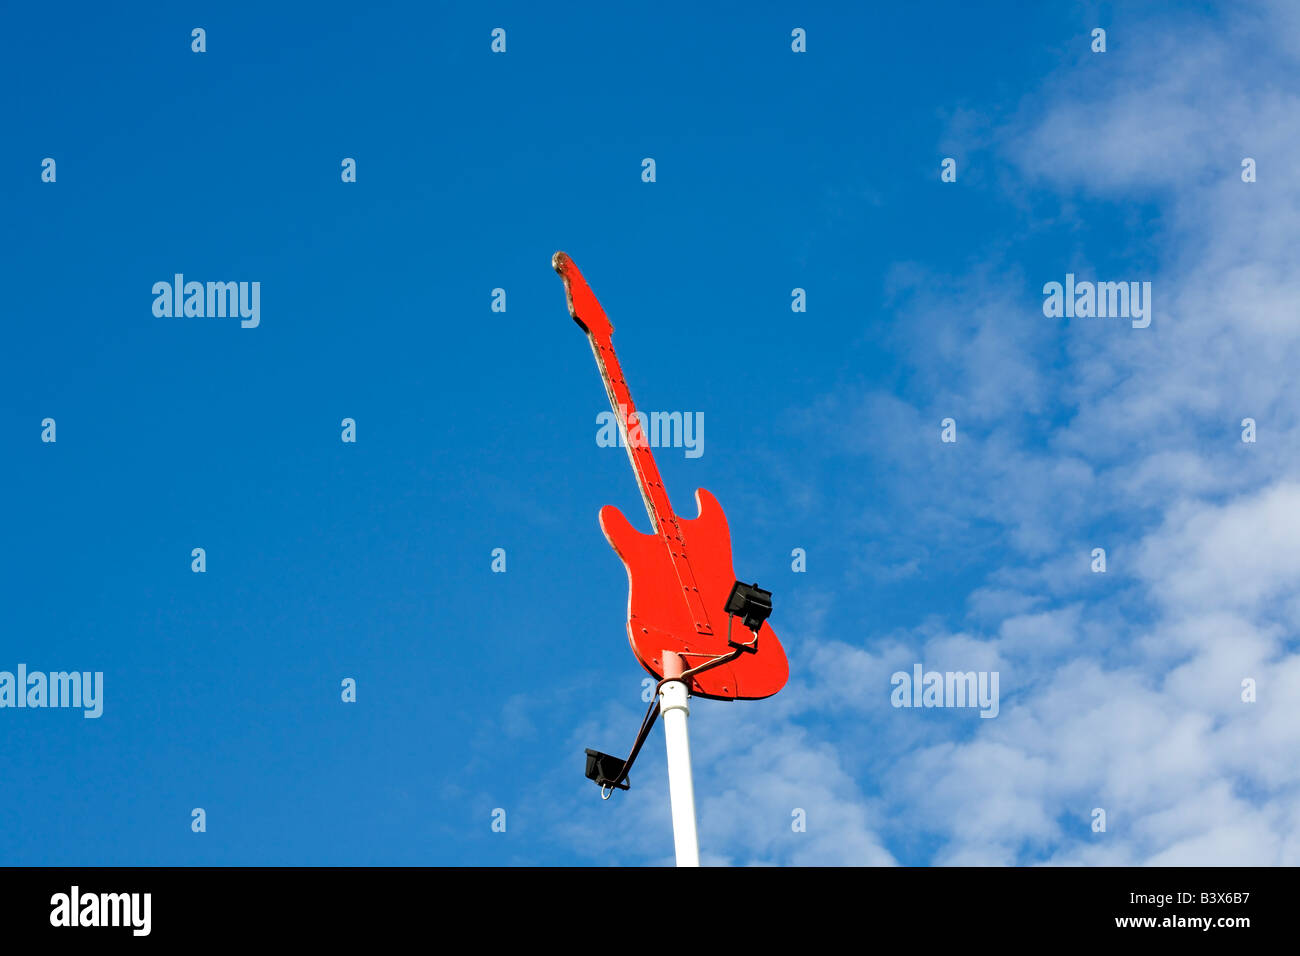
[0,3,1300,865]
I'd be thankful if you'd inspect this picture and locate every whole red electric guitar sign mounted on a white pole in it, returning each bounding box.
[551,252,789,700]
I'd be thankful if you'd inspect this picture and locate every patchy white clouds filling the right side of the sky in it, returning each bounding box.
[759,7,1300,865]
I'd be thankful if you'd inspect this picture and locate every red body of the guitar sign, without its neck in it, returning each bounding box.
[601,488,790,700]
